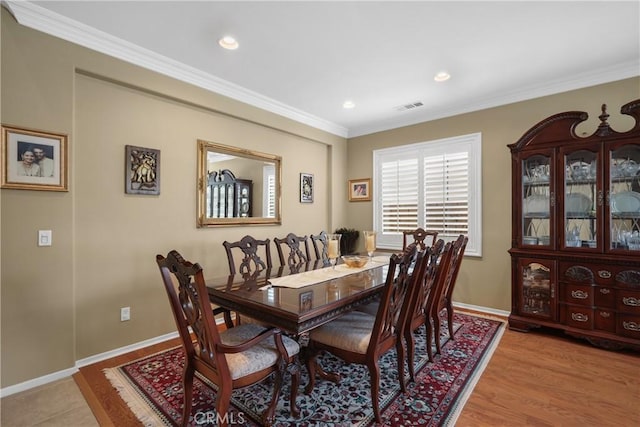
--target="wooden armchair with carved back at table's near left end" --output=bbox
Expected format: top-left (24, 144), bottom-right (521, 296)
top-left (156, 250), bottom-right (300, 426)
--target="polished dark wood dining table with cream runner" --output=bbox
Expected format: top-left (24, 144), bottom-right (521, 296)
top-left (207, 260), bottom-right (388, 337)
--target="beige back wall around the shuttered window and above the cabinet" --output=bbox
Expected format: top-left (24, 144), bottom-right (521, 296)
top-left (347, 78), bottom-right (640, 318)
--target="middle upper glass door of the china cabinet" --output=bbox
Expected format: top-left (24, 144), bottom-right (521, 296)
top-left (562, 148), bottom-right (603, 249)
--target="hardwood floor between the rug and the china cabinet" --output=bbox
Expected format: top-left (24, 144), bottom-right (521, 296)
top-left (457, 330), bottom-right (640, 427)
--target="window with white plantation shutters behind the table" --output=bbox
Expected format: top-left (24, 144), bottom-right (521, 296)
top-left (373, 133), bottom-right (482, 256)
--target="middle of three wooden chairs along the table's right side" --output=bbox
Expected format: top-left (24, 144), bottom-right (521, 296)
top-left (403, 239), bottom-right (452, 380)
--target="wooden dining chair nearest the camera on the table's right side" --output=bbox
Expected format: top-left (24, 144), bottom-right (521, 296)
top-left (306, 245), bottom-right (424, 422)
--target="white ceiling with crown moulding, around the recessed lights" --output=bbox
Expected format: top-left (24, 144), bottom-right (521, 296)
top-left (4, 0), bottom-right (640, 137)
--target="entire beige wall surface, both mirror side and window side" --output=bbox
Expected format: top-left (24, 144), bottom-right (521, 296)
top-left (0, 9), bottom-right (640, 387)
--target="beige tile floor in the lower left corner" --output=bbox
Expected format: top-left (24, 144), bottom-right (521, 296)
top-left (0, 377), bottom-right (98, 427)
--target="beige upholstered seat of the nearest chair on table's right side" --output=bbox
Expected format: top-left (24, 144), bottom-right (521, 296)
top-left (309, 311), bottom-right (376, 354)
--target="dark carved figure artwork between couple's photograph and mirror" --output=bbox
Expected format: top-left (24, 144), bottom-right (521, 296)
top-left (124, 145), bottom-right (160, 195)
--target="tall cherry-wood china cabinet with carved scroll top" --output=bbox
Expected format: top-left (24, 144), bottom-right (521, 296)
top-left (509, 99), bottom-right (640, 350)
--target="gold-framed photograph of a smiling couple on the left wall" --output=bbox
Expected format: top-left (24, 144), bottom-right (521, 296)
top-left (0, 125), bottom-right (69, 191)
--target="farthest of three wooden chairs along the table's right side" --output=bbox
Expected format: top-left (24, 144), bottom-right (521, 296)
top-left (432, 234), bottom-right (469, 344)
